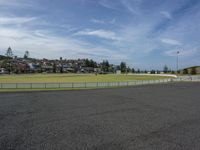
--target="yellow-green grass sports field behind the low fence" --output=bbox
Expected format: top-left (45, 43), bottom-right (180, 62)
top-left (0, 74), bottom-right (172, 83)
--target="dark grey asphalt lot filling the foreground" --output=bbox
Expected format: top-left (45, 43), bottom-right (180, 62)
top-left (0, 82), bottom-right (200, 150)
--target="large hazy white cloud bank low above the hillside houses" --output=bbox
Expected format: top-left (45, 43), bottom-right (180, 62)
top-left (0, 26), bottom-right (126, 61)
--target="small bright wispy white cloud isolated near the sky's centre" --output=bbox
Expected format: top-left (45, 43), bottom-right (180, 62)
top-left (74, 29), bottom-right (120, 40)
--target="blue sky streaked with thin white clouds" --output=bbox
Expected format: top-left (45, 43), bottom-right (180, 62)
top-left (0, 0), bottom-right (200, 70)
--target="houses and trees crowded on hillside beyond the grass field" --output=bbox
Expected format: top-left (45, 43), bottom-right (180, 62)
top-left (0, 55), bottom-right (110, 74)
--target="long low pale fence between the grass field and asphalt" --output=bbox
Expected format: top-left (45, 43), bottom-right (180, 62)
top-left (0, 79), bottom-right (172, 89)
